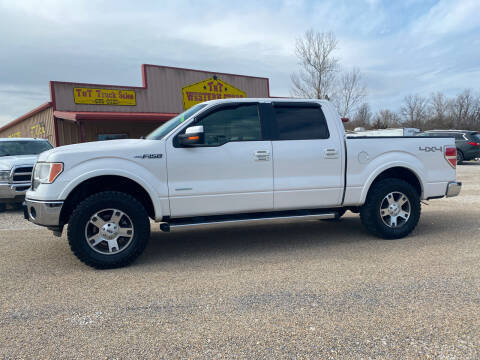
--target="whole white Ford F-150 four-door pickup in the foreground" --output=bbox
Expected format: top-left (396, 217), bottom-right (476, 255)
top-left (25, 99), bottom-right (461, 268)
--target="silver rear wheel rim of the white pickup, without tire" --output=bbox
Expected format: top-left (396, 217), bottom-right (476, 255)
top-left (380, 191), bottom-right (411, 228)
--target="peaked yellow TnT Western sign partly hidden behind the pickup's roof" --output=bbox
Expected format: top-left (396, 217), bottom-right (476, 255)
top-left (182, 76), bottom-right (247, 110)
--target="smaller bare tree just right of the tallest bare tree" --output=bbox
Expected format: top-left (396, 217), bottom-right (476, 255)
top-left (333, 68), bottom-right (367, 117)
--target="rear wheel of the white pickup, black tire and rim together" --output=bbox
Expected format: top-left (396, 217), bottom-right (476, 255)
top-left (360, 179), bottom-right (421, 239)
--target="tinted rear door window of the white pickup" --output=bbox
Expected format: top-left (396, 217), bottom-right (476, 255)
top-left (274, 104), bottom-right (330, 140)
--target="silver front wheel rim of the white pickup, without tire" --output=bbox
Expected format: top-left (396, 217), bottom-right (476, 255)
top-left (85, 209), bottom-right (134, 255)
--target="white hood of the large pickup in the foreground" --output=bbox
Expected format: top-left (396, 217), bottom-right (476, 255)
top-left (38, 139), bottom-right (162, 165)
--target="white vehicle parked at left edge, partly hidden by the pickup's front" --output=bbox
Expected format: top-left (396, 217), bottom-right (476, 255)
top-left (0, 138), bottom-right (52, 211)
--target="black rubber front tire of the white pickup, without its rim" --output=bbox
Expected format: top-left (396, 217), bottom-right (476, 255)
top-left (67, 191), bottom-right (150, 269)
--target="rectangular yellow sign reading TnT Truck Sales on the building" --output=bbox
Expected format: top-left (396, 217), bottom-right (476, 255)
top-left (73, 88), bottom-right (136, 106)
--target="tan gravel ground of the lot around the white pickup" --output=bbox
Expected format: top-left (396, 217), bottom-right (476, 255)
top-left (0, 164), bottom-right (480, 359)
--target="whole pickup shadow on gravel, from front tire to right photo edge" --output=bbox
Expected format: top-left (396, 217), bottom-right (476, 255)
top-left (134, 210), bottom-right (478, 266)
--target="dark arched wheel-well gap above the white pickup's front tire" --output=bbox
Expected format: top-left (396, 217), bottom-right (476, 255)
top-left (60, 175), bottom-right (158, 224)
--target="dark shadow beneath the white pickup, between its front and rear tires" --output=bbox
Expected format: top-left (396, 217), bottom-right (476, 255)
top-left (138, 217), bottom-right (366, 263)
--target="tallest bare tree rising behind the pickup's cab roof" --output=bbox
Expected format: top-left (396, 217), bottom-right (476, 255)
top-left (291, 30), bottom-right (338, 99)
